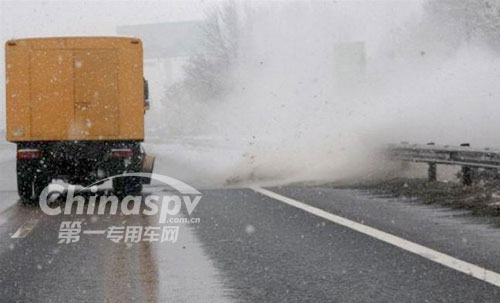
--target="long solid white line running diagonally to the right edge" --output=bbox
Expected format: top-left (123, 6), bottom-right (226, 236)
top-left (251, 187), bottom-right (500, 287)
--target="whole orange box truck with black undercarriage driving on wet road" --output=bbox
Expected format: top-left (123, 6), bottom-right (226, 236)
top-left (5, 37), bottom-right (154, 201)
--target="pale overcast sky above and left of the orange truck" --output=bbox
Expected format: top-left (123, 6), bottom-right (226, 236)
top-left (0, 0), bottom-right (208, 129)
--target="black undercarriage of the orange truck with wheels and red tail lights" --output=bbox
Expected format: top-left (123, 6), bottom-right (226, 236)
top-left (16, 141), bottom-right (148, 202)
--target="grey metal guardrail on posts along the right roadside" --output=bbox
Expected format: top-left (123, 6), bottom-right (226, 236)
top-left (387, 142), bottom-right (500, 185)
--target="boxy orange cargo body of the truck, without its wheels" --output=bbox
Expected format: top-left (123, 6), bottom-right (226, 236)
top-left (5, 37), bottom-right (144, 142)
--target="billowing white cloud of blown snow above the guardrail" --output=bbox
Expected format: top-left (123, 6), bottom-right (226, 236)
top-left (153, 1), bottom-right (500, 185)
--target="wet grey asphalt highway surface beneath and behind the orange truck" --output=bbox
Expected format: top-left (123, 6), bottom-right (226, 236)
top-left (0, 147), bottom-right (500, 303)
